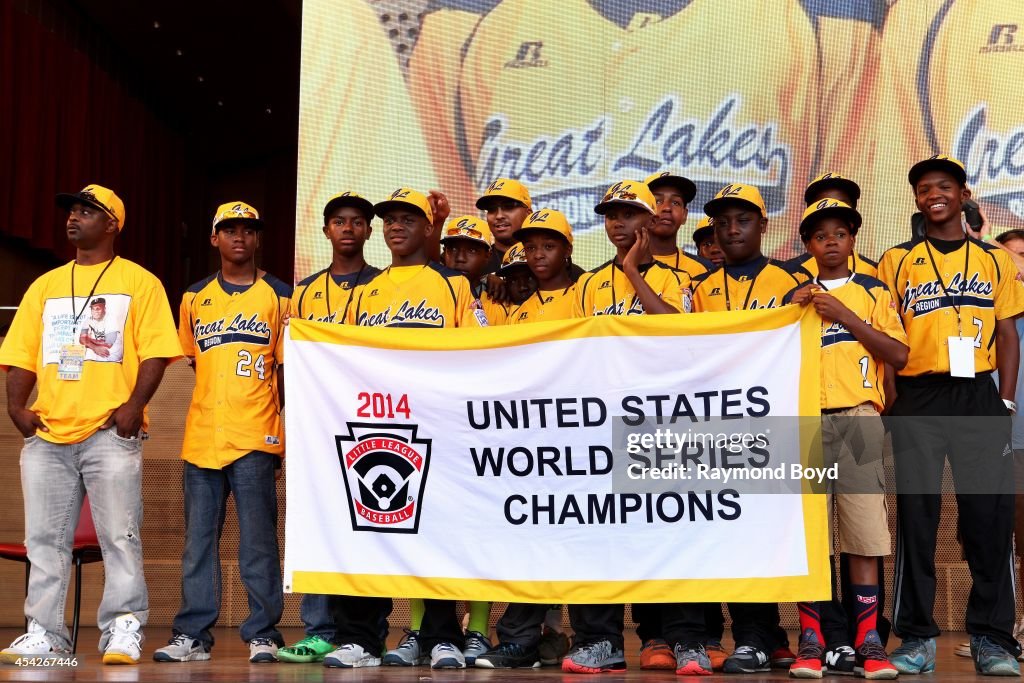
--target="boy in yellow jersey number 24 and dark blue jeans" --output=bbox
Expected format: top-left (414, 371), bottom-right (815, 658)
top-left (153, 202), bottom-right (292, 663)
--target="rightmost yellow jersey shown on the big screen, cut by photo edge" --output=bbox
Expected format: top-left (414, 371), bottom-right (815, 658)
top-left (861, 0), bottom-right (1024, 253)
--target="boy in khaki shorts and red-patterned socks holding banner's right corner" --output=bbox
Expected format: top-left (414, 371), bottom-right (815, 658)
top-left (784, 199), bottom-right (908, 679)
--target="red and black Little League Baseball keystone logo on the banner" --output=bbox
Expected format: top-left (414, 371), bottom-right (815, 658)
top-left (335, 422), bottom-right (430, 533)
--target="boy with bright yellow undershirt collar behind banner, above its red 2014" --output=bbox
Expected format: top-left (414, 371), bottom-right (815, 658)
top-left (344, 187), bottom-right (487, 669)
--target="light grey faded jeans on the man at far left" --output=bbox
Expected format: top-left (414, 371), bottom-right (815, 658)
top-left (22, 428), bottom-right (150, 651)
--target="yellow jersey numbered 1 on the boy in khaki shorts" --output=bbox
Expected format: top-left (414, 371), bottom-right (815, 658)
top-left (783, 272), bottom-right (907, 412)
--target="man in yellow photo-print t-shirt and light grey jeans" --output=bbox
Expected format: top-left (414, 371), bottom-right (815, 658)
top-left (0, 185), bottom-right (181, 664)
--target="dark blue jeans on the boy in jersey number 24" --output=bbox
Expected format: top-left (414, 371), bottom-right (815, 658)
top-left (172, 451), bottom-right (285, 647)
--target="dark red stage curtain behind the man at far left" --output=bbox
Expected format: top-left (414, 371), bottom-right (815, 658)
top-left (0, 0), bottom-right (187, 288)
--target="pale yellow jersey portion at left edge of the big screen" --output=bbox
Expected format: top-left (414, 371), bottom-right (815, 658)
top-left (295, 0), bottom-right (440, 279)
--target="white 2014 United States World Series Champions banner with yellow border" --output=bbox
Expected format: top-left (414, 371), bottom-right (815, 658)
top-left (285, 306), bottom-right (828, 603)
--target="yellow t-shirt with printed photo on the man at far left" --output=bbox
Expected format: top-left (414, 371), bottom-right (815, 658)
top-left (0, 256), bottom-right (181, 443)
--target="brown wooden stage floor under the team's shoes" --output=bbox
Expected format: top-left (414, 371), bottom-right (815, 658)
top-left (0, 627), bottom-right (991, 683)
